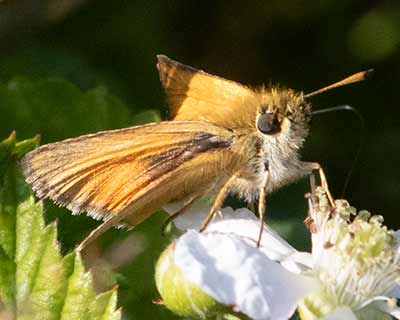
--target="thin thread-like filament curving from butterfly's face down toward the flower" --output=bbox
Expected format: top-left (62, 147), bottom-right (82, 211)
top-left (311, 105), bottom-right (365, 198)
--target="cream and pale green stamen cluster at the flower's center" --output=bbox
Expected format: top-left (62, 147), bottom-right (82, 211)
top-left (311, 189), bottom-right (400, 310)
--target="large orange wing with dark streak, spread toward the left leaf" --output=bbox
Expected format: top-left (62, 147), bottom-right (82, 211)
top-left (22, 121), bottom-right (236, 225)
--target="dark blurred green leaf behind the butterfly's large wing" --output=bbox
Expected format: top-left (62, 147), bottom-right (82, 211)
top-left (0, 77), bottom-right (132, 142)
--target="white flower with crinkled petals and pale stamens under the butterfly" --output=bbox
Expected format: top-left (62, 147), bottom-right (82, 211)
top-left (164, 191), bottom-right (400, 320)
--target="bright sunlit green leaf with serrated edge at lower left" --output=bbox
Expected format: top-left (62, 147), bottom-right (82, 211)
top-left (0, 133), bottom-right (121, 320)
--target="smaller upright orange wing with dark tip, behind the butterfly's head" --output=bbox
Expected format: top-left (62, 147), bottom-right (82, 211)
top-left (157, 55), bottom-right (259, 128)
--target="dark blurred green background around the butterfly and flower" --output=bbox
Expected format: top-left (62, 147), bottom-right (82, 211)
top-left (0, 0), bottom-right (400, 319)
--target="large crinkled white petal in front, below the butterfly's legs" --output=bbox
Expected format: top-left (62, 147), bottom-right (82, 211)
top-left (175, 231), bottom-right (319, 320)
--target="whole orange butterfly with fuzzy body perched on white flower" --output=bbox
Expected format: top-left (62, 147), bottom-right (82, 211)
top-left (22, 55), bottom-right (372, 250)
